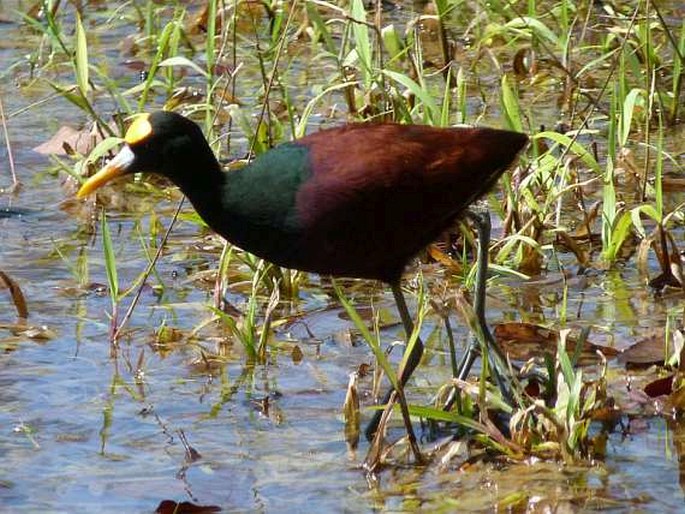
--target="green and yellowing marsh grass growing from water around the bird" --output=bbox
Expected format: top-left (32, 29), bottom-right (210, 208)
top-left (0, 0), bottom-right (685, 505)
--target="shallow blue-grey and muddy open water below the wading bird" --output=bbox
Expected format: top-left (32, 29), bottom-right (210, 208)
top-left (0, 2), bottom-right (685, 512)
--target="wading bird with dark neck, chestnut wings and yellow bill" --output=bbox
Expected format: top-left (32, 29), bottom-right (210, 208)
top-left (77, 111), bottom-right (528, 452)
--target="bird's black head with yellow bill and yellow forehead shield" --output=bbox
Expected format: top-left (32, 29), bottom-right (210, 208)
top-left (77, 111), bottom-right (216, 198)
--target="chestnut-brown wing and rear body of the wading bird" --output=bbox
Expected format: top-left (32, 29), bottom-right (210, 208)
top-left (296, 124), bottom-right (527, 282)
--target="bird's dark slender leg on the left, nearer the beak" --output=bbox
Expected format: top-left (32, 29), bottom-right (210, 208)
top-left (366, 283), bottom-right (423, 460)
